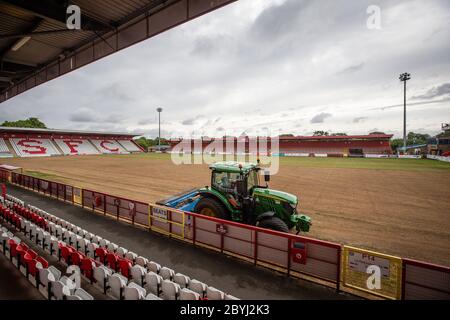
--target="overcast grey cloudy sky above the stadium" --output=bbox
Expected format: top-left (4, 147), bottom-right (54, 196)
top-left (0, 0), bottom-right (450, 137)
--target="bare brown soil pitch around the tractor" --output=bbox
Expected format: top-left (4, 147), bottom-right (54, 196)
top-left (2, 156), bottom-right (450, 265)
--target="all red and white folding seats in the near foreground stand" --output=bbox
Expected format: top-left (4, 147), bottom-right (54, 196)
top-left (0, 195), bottom-right (237, 300)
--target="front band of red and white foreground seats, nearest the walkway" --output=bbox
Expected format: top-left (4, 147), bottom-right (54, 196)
top-left (2, 197), bottom-right (236, 300)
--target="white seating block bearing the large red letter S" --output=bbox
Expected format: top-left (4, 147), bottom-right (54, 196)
top-left (9, 137), bottom-right (60, 157)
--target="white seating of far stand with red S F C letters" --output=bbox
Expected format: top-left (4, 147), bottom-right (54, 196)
top-left (0, 137), bottom-right (141, 157)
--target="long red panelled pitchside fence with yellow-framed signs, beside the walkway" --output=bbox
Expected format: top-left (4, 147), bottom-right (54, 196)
top-left (0, 169), bottom-right (450, 299)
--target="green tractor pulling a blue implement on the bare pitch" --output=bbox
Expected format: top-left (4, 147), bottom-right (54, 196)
top-left (158, 161), bottom-right (311, 233)
